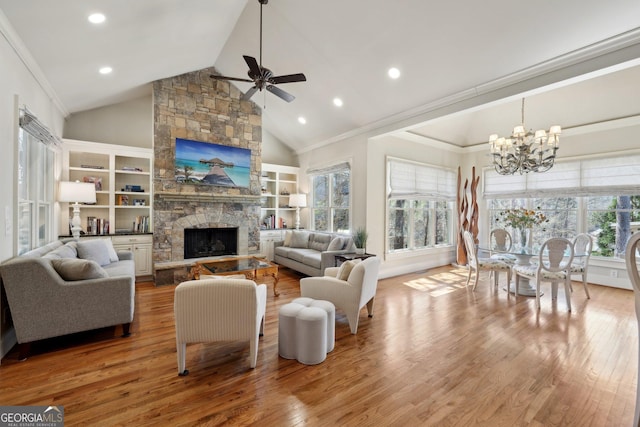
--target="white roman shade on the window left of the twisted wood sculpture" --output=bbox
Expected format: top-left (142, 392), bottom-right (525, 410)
top-left (387, 157), bottom-right (456, 200)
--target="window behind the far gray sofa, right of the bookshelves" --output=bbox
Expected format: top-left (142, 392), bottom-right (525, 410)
top-left (308, 163), bottom-right (351, 233)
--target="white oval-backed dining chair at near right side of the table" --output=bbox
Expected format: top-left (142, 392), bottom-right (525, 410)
top-left (513, 237), bottom-right (573, 311)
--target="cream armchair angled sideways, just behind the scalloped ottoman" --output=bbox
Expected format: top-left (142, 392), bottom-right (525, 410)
top-left (300, 257), bottom-right (380, 334)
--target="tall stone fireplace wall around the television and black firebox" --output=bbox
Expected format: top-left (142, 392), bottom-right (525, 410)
top-left (153, 68), bottom-right (262, 272)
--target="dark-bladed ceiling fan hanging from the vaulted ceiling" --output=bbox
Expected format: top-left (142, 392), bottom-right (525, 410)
top-left (210, 0), bottom-right (307, 102)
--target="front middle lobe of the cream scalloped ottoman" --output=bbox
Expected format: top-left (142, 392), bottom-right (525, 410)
top-left (296, 306), bottom-right (327, 365)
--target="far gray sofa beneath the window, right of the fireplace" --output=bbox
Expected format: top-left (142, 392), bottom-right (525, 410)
top-left (273, 230), bottom-right (355, 276)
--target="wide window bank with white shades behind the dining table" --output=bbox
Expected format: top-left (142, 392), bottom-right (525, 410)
top-left (484, 154), bottom-right (640, 258)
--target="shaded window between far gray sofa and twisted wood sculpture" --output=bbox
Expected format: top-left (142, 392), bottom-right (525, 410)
top-left (387, 158), bottom-right (456, 253)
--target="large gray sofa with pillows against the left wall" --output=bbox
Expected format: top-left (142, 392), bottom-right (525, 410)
top-left (0, 239), bottom-right (135, 359)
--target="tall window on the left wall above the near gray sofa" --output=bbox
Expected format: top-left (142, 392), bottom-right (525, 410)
top-left (17, 122), bottom-right (55, 255)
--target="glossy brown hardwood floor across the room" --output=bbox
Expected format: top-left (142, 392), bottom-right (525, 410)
top-left (0, 267), bottom-right (638, 426)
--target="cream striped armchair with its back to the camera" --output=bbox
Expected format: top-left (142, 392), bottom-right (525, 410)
top-left (173, 279), bottom-right (267, 375)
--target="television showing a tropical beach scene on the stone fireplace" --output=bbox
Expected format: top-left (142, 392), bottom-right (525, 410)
top-left (175, 138), bottom-right (251, 188)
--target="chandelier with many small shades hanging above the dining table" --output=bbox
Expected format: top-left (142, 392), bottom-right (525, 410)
top-left (489, 98), bottom-right (562, 175)
